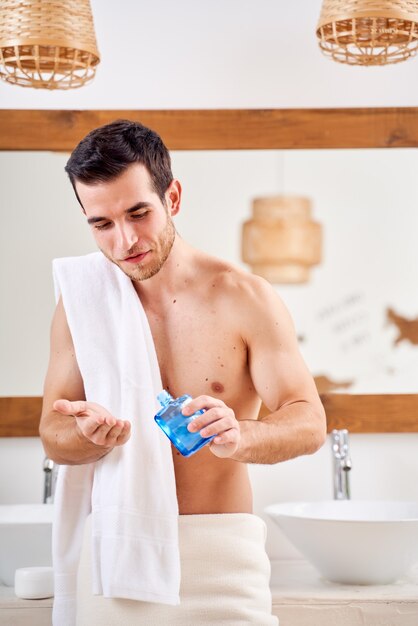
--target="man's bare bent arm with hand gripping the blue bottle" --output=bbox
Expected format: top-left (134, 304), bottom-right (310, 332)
top-left (182, 276), bottom-right (326, 464)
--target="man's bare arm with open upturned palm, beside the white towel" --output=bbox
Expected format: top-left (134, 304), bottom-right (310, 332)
top-left (39, 300), bottom-right (130, 465)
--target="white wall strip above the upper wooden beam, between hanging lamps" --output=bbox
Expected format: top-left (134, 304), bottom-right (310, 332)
top-left (0, 0), bottom-right (418, 109)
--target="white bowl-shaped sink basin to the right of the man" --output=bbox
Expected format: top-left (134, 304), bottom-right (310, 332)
top-left (265, 500), bottom-right (418, 585)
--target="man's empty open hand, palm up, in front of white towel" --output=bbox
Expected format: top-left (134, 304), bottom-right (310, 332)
top-left (53, 400), bottom-right (131, 448)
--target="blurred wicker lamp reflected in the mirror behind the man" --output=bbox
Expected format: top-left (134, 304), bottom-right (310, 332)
top-left (242, 196), bottom-right (322, 284)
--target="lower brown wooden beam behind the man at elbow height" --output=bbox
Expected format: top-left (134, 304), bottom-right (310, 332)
top-left (0, 393), bottom-right (418, 437)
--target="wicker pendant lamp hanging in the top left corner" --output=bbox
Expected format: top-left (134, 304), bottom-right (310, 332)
top-left (0, 0), bottom-right (100, 89)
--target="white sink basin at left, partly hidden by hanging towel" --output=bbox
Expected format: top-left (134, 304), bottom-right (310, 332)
top-left (0, 504), bottom-right (54, 587)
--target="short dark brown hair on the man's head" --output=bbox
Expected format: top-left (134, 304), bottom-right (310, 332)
top-left (65, 120), bottom-right (173, 204)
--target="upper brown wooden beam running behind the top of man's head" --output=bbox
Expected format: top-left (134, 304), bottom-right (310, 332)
top-left (0, 107), bottom-right (418, 152)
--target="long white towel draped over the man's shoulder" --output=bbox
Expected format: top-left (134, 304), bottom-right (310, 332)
top-left (53, 252), bottom-right (180, 626)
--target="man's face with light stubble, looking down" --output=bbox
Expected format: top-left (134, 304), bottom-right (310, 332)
top-left (76, 163), bottom-right (175, 281)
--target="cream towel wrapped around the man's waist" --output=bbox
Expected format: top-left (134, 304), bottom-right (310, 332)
top-left (77, 513), bottom-right (278, 626)
